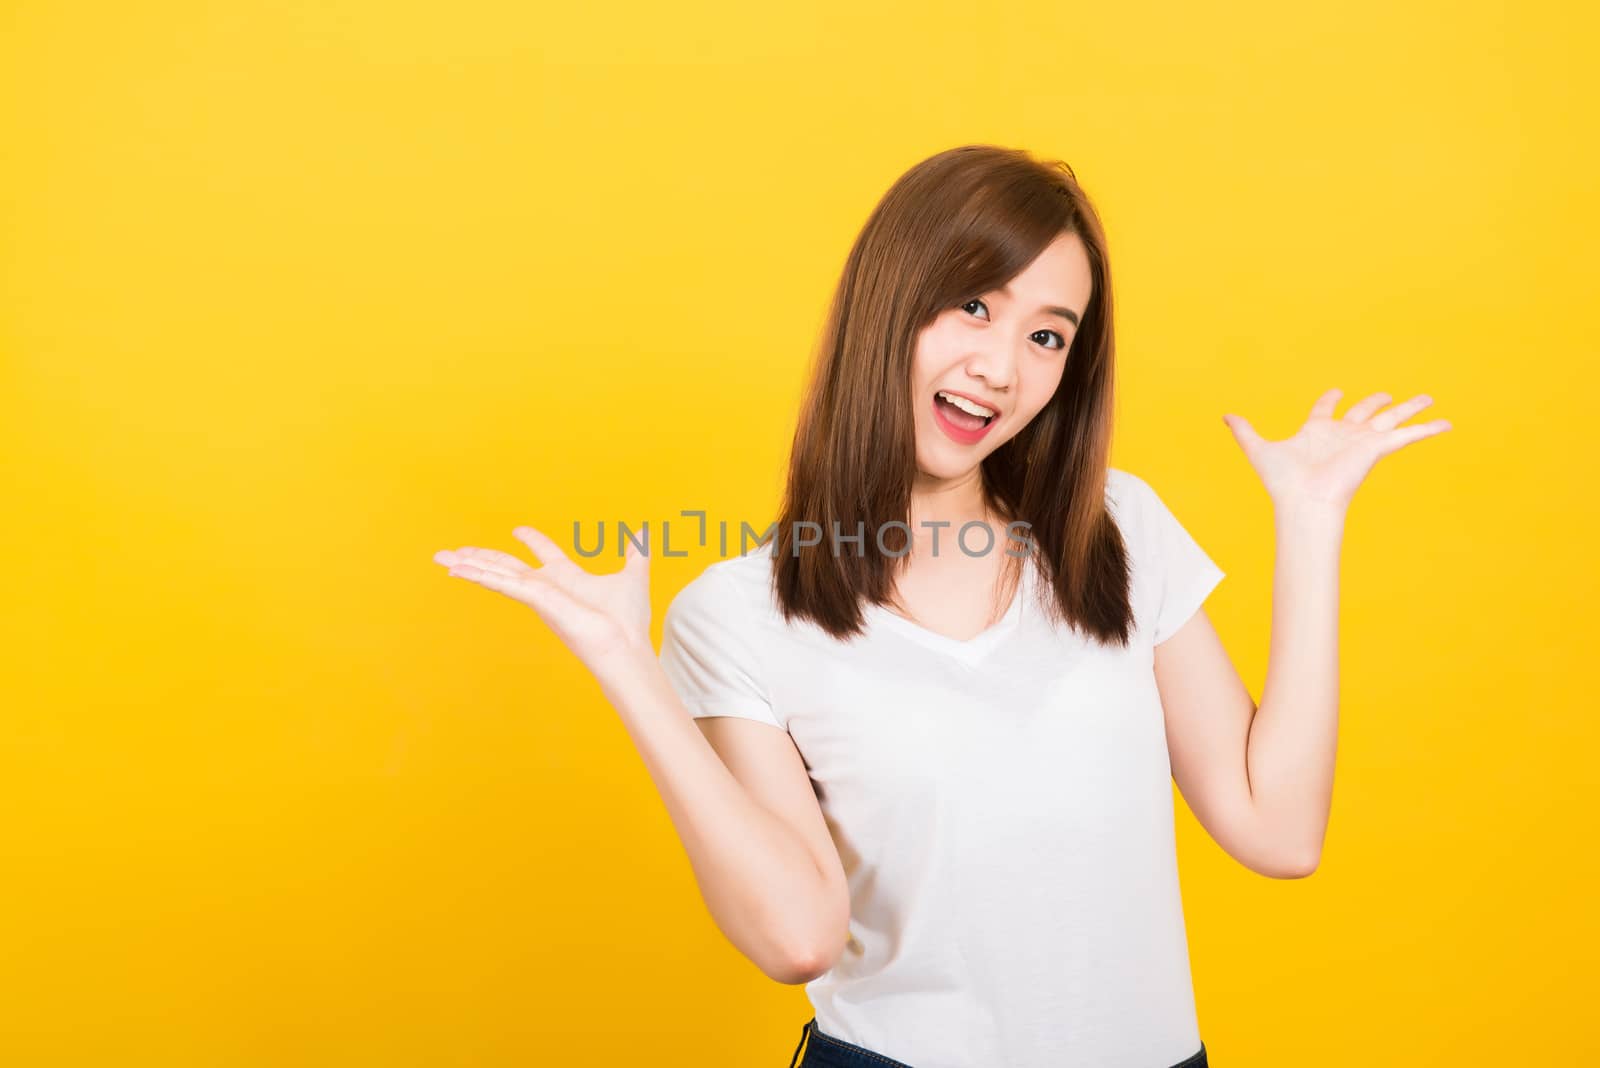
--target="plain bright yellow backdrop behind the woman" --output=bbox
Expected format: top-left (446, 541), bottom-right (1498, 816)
top-left (0, 0), bottom-right (1600, 1068)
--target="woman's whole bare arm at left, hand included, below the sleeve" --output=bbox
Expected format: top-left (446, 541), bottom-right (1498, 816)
top-left (434, 526), bottom-right (850, 983)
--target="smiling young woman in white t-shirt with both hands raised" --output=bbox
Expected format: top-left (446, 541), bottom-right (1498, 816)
top-left (435, 145), bottom-right (1450, 1068)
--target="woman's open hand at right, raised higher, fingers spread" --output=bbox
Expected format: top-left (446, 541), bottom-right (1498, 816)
top-left (1222, 389), bottom-right (1450, 508)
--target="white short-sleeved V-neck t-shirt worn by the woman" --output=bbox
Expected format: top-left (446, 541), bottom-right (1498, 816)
top-left (661, 468), bottom-right (1224, 1068)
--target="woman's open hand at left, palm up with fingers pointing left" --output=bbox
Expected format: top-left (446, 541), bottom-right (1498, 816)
top-left (434, 526), bottom-right (654, 675)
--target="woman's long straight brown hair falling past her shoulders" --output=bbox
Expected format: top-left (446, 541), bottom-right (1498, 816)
top-left (773, 144), bottom-right (1133, 644)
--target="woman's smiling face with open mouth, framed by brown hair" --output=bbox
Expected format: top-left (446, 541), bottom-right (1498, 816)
top-left (912, 233), bottom-right (1091, 481)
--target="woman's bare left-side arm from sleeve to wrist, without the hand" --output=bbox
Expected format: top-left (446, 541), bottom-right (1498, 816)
top-left (597, 646), bottom-right (850, 983)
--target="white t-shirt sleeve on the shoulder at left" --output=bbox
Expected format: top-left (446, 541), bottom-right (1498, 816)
top-left (659, 572), bottom-right (786, 731)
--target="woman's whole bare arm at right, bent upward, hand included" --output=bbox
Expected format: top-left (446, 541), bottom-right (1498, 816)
top-left (1155, 390), bottom-right (1450, 878)
